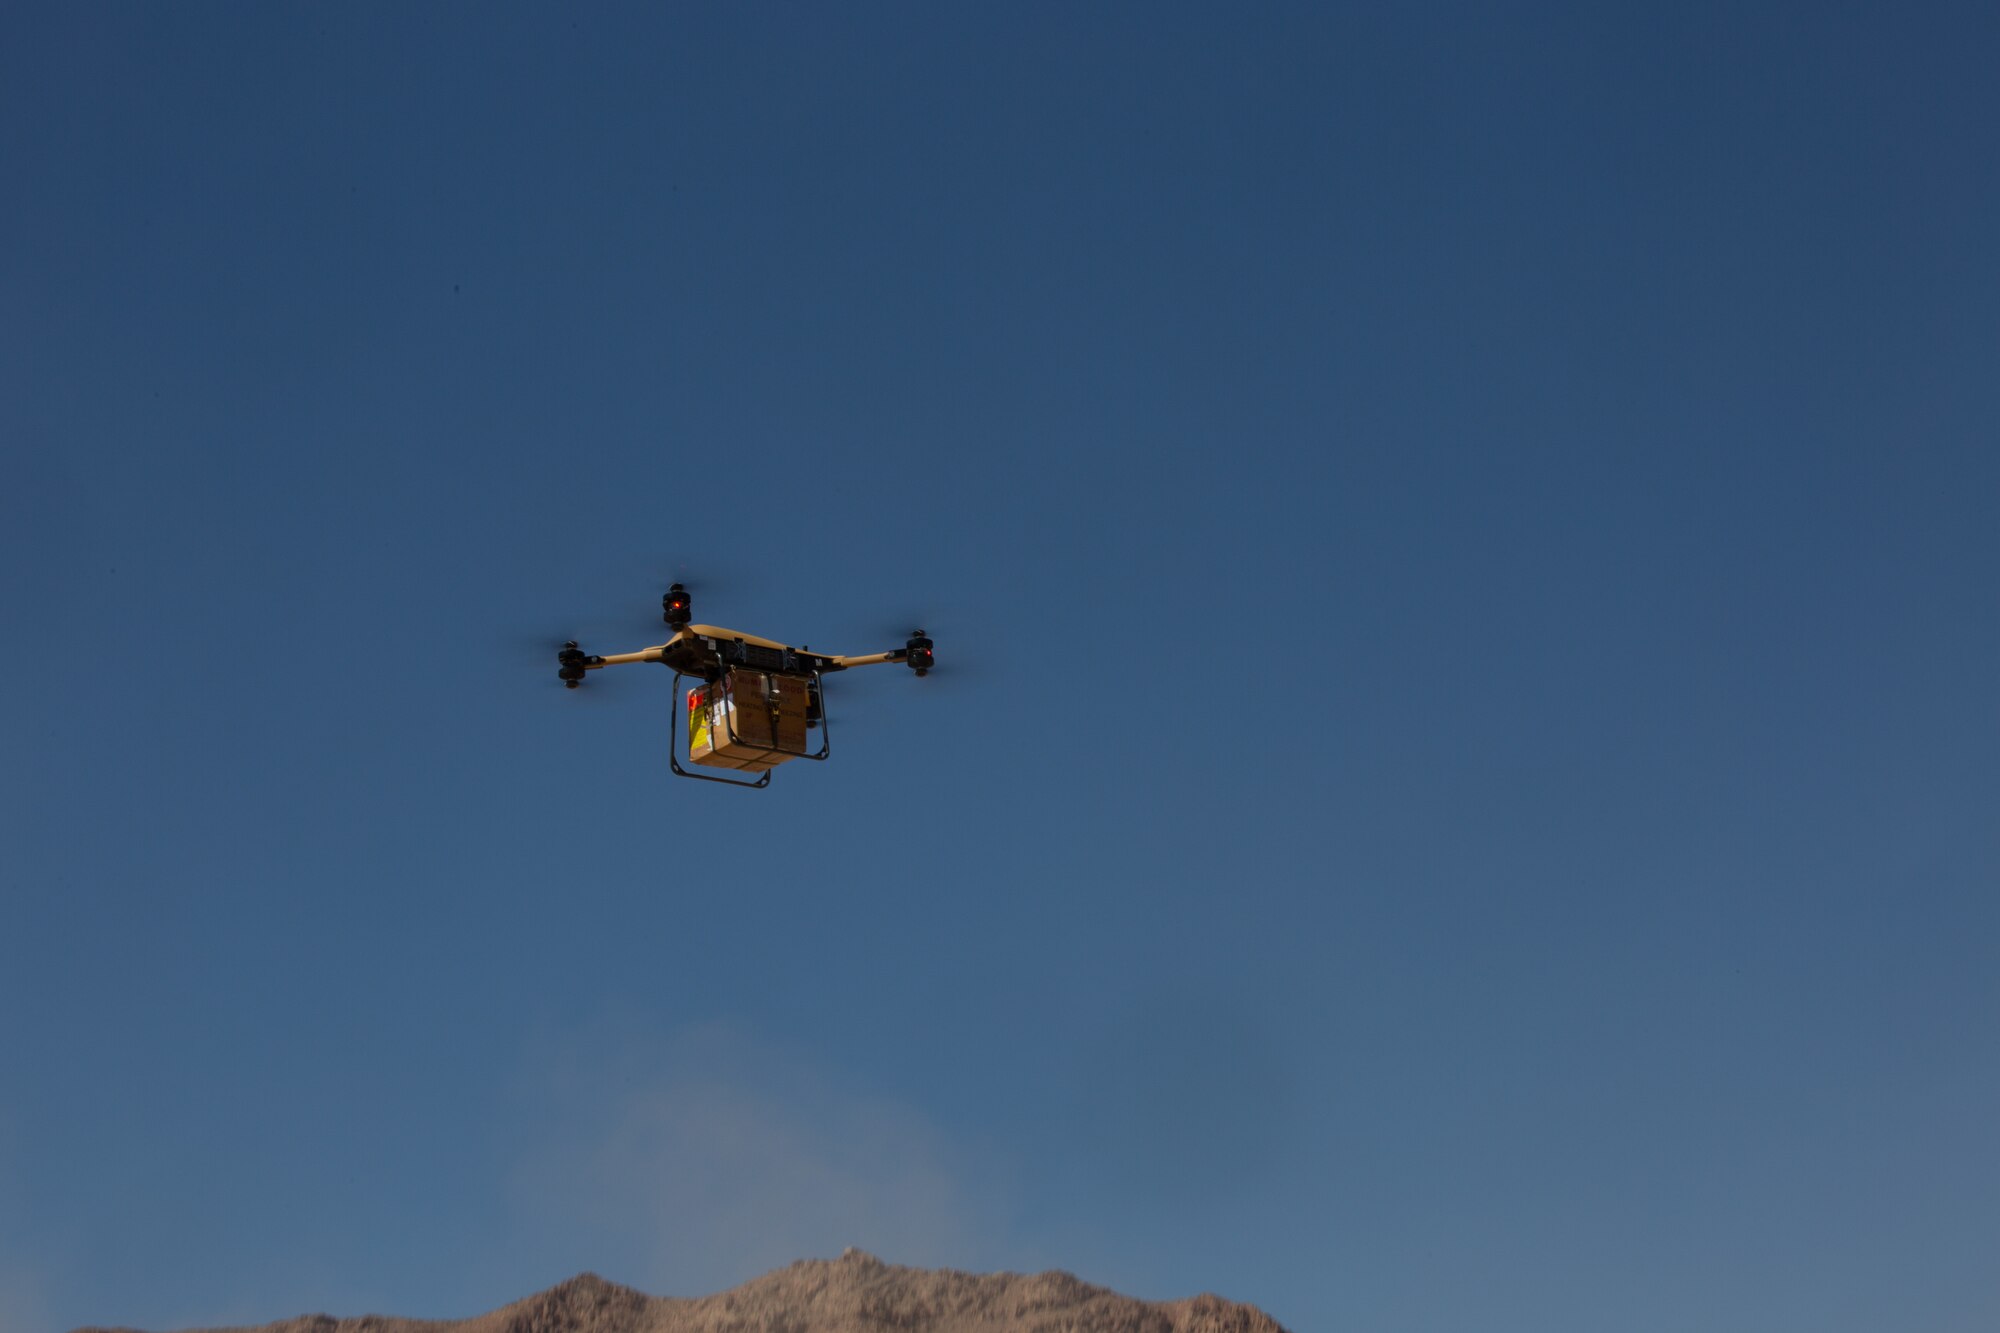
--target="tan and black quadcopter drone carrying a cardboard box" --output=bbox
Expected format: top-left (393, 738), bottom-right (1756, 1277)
top-left (556, 582), bottom-right (938, 787)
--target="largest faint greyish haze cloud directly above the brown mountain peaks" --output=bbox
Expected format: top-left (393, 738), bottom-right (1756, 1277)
top-left (510, 1027), bottom-right (1006, 1295)
